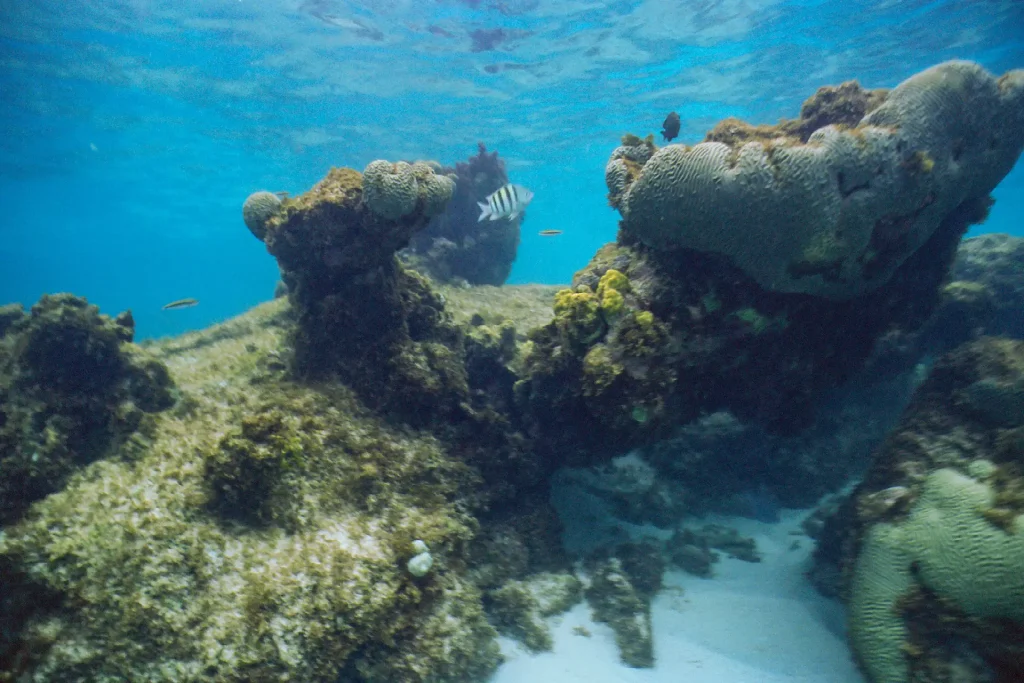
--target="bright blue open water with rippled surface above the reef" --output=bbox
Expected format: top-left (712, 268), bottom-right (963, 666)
top-left (0, 0), bottom-right (1024, 337)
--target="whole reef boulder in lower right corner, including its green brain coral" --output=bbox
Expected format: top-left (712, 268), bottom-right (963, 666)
top-left (816, 338), bottom-right (1024, 683)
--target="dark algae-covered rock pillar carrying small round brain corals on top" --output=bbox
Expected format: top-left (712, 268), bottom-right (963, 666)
top-left (266, 162), bottom-right (466, 416)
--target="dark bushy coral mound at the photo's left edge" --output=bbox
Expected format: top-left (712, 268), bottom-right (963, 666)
top-left (0, 294), bottom-right (174, 523)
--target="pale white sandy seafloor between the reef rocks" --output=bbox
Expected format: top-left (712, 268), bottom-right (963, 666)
top-left (490, 481), bottom-right (864, 683)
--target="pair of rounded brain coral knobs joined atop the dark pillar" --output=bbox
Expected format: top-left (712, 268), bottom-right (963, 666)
top-left (362, 160), bottom-right (455, 220)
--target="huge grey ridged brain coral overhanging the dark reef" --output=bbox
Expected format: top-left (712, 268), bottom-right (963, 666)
top-left (606, 61), bottom-right (1024, 298)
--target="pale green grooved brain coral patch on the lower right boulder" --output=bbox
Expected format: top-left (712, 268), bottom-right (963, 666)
top-left (850, 468), bottom-right (1024, 683)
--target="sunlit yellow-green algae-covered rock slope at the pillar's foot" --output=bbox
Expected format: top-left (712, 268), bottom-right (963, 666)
top-left (0, 301), bottom-right (500, 683)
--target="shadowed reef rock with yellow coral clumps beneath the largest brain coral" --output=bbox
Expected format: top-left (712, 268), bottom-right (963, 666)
top-left (516, 187), bottom-right (987, 464)
